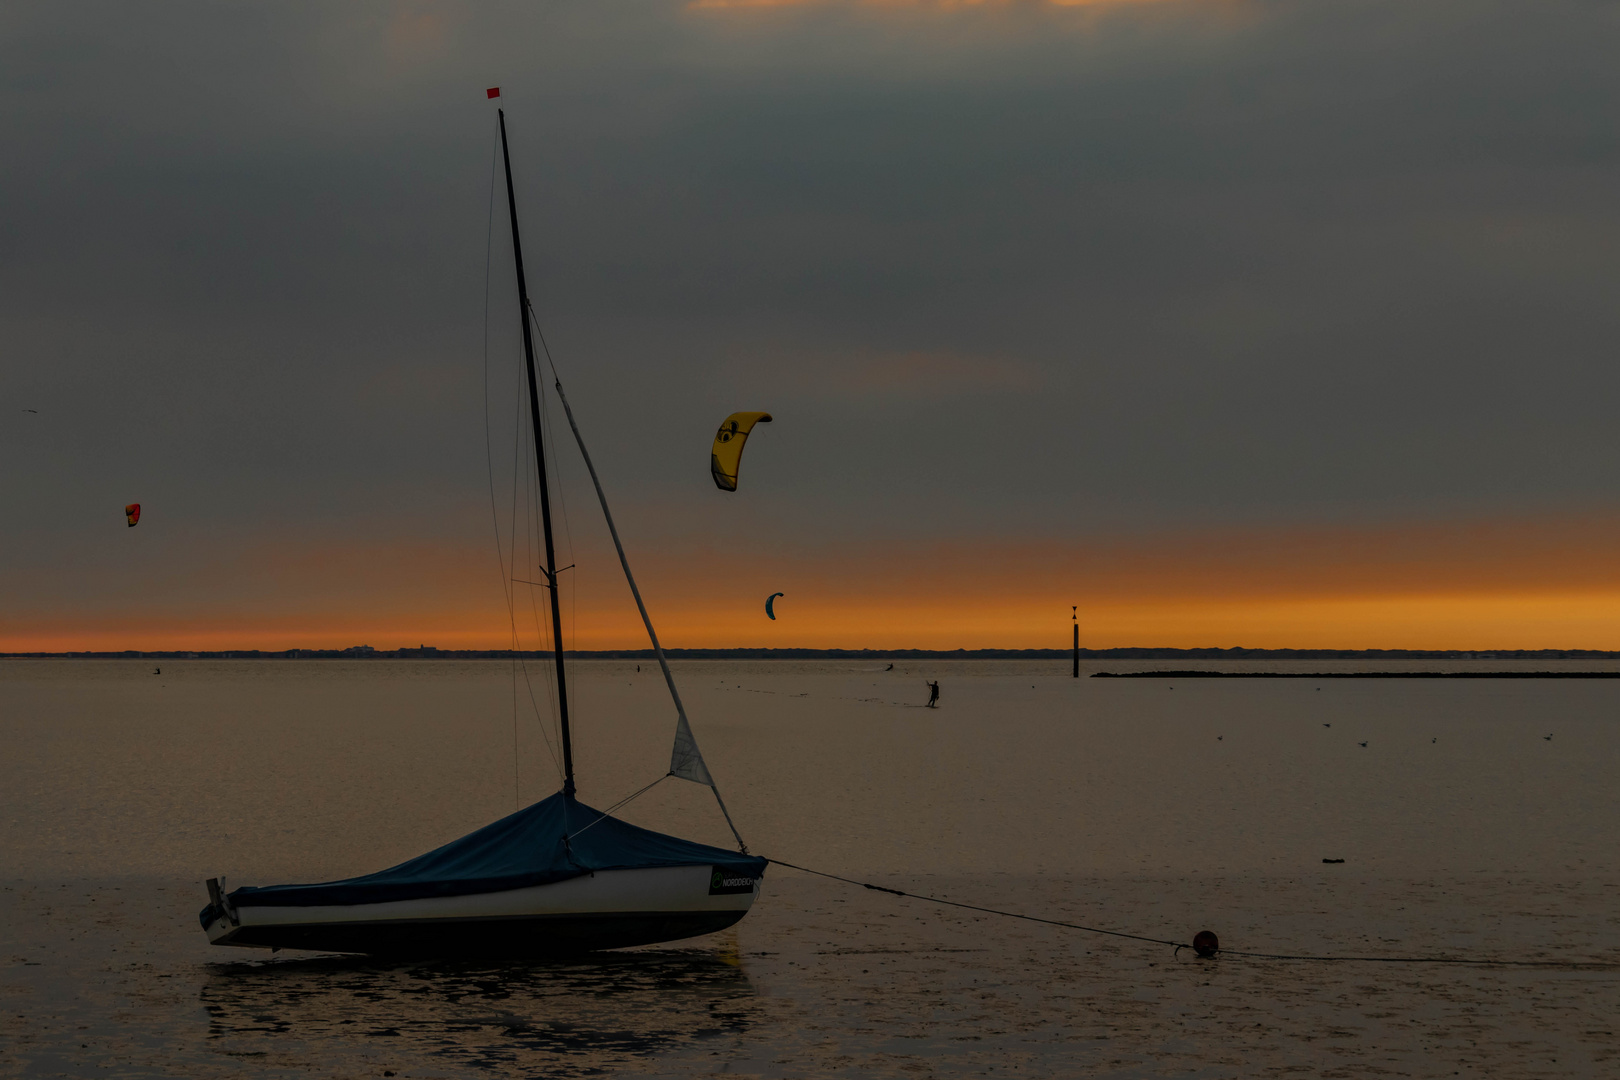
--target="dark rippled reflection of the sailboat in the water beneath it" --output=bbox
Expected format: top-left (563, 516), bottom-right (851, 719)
top-left (199, 947), bottom-right (758, 1075)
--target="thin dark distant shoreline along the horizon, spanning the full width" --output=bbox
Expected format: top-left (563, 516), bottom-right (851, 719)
top-left (0, 646), bottom-right (1620, 663)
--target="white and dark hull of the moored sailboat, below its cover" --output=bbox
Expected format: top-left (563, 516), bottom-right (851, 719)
top-left (204, 866), bottom-right (760, 957)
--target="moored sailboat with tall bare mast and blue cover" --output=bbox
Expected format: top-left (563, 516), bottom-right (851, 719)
top-left (199, 107), bottom-right (766, 957)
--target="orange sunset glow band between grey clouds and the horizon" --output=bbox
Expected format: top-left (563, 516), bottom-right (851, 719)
top-left (9, 517), bottom-right (1620, 653)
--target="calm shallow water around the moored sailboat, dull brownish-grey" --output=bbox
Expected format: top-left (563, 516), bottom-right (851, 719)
top-left (0, 661), bottom-right (1620, 1077)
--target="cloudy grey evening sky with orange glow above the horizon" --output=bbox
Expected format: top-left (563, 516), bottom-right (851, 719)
top-left (0, 0), bottom-right (1620, 651)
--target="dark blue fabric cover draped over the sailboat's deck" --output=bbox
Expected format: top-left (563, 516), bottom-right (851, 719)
top-left (230, 793), bottom-right (766, 907)
